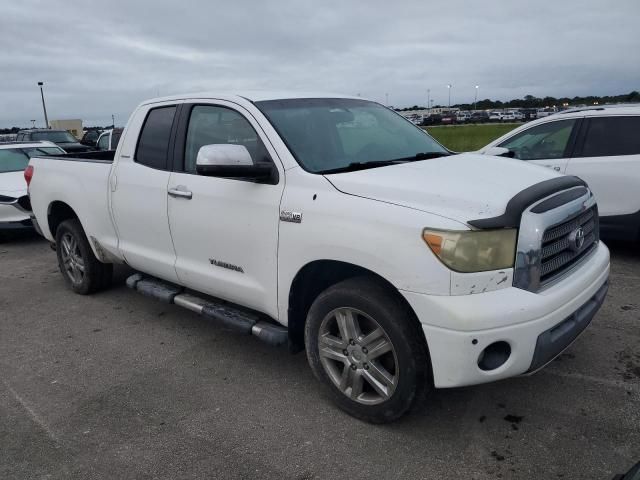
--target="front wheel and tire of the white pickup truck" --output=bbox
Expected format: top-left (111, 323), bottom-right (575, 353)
top-left (305, 277), bottom-right (432, 423)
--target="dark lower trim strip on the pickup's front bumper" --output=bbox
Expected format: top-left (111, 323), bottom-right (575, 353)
top-left (528, 281), bottom-right (609, 373)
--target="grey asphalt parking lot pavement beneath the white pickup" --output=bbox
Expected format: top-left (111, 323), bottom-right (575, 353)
top-left (0, 236), bottom-right (640, 480)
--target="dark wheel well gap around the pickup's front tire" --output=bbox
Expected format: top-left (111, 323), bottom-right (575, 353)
top-left (287, 259), bottom-right (426, 352)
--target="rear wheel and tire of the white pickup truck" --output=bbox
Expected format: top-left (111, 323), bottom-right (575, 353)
top-left (56, 219), bottom-right (113, 295)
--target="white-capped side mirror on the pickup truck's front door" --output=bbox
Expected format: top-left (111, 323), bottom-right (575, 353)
top-left (196, 143), bottom-right (278, 185)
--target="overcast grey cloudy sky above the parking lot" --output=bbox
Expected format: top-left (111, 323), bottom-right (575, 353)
top-left (0, 0), bottom-right (640, 127)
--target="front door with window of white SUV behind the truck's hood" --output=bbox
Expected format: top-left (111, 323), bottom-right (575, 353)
top-left (497, 118), bottom-right (581, 173)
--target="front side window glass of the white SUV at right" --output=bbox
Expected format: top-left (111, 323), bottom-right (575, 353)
top-left (498, 119), bottom-right (576, 160)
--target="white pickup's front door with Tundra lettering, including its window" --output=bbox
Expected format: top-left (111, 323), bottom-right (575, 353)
top-left (169, 102), bottom-right (284, 317)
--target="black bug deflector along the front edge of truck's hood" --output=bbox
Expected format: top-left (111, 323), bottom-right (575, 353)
top-left (467, 176), bottom-right (587, 229)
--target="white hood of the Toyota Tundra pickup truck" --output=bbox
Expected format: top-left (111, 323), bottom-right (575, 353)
top-left (326, 153), bottom-right (561, 223)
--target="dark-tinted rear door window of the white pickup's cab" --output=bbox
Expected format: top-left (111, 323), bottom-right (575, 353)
top-left (135, 106), bottom-right (176, 170)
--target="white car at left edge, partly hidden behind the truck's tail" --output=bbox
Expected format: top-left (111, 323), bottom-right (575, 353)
top-left (0, 142), bottom-right (65, 236)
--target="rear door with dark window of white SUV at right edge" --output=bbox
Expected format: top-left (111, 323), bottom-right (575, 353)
top-left (567, 115), bottom-right (640, 217)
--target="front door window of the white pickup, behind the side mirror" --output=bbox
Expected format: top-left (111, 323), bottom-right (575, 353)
top-left (184, 105), bottom-right (271, 173)
